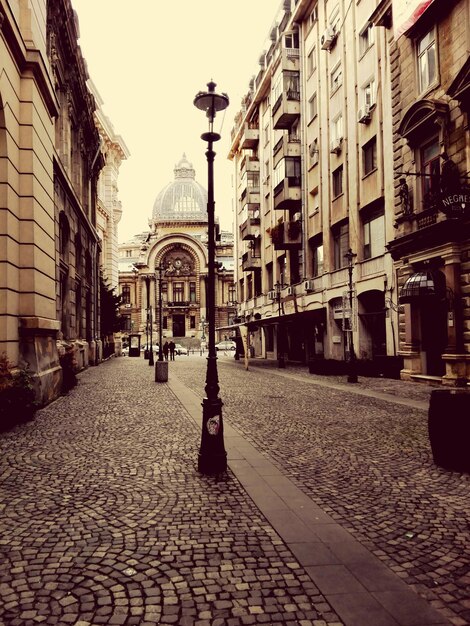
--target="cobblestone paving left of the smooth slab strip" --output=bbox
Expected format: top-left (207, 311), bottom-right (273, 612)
top-left (0, 357), bottom-right (341, 626)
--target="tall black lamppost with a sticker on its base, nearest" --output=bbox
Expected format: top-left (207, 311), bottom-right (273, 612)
top-left (194, 81), bottom-right (229, 474)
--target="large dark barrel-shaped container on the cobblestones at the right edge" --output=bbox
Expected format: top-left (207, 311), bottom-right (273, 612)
top-left (428, 389), bottom-right (470, 472)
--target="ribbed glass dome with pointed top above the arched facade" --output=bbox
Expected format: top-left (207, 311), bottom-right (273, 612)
top-left (152, 154), bottom-right (207, 222)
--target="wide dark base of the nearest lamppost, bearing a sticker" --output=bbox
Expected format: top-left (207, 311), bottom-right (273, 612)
top-left (197, 398), bottom-right (227, 474)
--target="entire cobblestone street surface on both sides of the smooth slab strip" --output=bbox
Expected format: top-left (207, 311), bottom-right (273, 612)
top-left (0, 355), bottom-right (470, 626)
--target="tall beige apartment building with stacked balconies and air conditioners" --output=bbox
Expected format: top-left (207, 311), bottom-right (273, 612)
top-left (230, 0), bottom-right (398, 371)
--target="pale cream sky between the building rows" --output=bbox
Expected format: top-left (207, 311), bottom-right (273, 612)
top-left (72, 0), bottom-right (281, 242)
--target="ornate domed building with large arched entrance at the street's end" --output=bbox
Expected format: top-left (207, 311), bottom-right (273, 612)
top-left (119, 155), bottom-right (235, 348)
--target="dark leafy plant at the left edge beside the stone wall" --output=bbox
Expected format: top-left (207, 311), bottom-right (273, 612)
top-left (0, 354), bottom-right (39, 429)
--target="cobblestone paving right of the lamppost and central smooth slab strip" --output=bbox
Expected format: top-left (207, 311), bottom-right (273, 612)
top-left (173, 357), bottom-right (470, 626)
